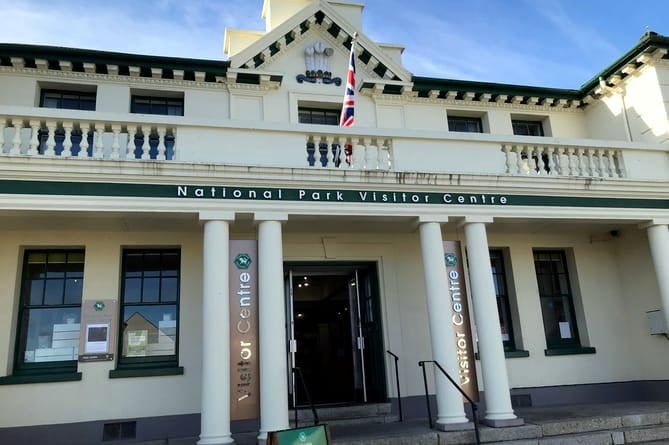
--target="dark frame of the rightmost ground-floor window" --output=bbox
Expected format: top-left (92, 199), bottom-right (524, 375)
top-left (532, 249), bottom-right (582, 351)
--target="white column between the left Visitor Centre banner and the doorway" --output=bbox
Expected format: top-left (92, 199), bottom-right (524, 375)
top-left (255, 213), bottom-right (289, 441)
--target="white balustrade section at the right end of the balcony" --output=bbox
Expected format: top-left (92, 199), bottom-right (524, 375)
top-left (502, 144), bottom-right (625, 178)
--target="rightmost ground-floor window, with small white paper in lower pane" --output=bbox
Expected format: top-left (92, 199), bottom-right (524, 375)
top-left (534, 250), bottom-right (580, 349)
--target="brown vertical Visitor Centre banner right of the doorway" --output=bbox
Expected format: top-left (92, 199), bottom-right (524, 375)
top-left (444, 241), bottom-right (479, 402)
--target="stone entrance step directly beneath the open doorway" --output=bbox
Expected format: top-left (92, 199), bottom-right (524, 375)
top-left (289, 403), bottom-right (398, 426)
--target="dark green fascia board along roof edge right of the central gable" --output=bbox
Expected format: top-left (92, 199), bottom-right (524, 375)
top-left (412, 76), bottom-right (583, 100)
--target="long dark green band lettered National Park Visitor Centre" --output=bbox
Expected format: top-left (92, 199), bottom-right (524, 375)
top-left (0, 180), bottom-right (669, 209)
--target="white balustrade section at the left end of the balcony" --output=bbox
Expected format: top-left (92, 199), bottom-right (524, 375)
top-left (0, 117), bottom-right (176, 160)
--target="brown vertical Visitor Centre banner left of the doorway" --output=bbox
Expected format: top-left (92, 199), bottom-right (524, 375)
top-left (228, 240), bottom-right (260, 420)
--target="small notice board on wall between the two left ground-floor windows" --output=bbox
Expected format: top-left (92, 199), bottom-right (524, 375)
top-left (79, 300), bottom-right (117, 362)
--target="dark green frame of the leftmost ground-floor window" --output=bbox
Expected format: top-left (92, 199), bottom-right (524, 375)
top-left (13, 248), bottom-right (86, 376)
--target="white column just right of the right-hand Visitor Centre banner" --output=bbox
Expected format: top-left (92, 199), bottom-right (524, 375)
top-left (464, 218), bottom-right (523, 426)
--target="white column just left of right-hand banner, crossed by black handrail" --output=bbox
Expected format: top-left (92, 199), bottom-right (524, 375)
top-left (419, 217), bottom-right (469, 430)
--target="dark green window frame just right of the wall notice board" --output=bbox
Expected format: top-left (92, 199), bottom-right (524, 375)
top-left (110, 247), bottom-right (183, 377)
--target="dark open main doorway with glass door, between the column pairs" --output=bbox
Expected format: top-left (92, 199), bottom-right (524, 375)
top-left (285, 262), bottom-right (386, 406)
